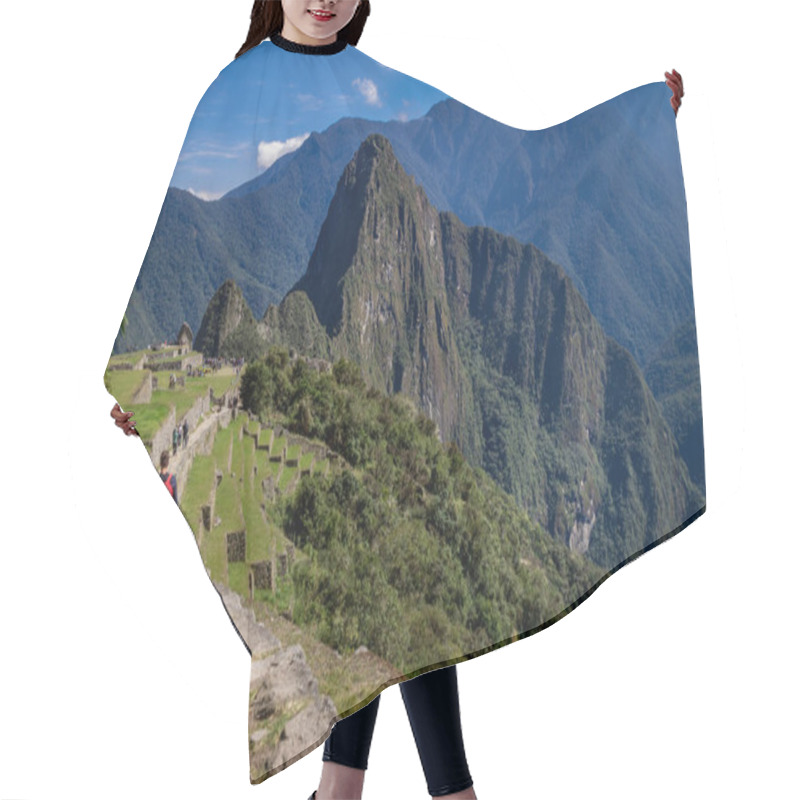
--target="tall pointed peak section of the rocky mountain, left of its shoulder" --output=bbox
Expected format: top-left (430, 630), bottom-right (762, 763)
top-left (294, 135), bottom-right (470, 439)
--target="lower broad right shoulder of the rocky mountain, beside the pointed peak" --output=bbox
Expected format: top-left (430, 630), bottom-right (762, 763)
top-left (432, 198), bottom-right (704, 566)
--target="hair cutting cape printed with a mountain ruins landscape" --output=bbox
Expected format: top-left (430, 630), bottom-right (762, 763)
top-left (105, 31), bottom-right (705, 783)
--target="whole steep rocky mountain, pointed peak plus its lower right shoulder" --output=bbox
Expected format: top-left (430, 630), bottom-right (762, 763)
top-left (216, 134), bottom-right (703, 565)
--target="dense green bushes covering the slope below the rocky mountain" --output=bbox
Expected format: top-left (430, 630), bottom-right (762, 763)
top-left (241, 348), bottom-right (603, 671)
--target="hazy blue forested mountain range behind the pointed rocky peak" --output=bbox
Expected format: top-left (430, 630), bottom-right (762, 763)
top-left (115, 85), bottom-right (693, 366)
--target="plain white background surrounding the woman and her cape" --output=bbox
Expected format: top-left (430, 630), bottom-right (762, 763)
top-left (0, 0), bottom-right (800, 800)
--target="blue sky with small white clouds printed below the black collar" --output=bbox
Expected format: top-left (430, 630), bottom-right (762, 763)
top-left (170, 40), bottom-right (447, 200)
